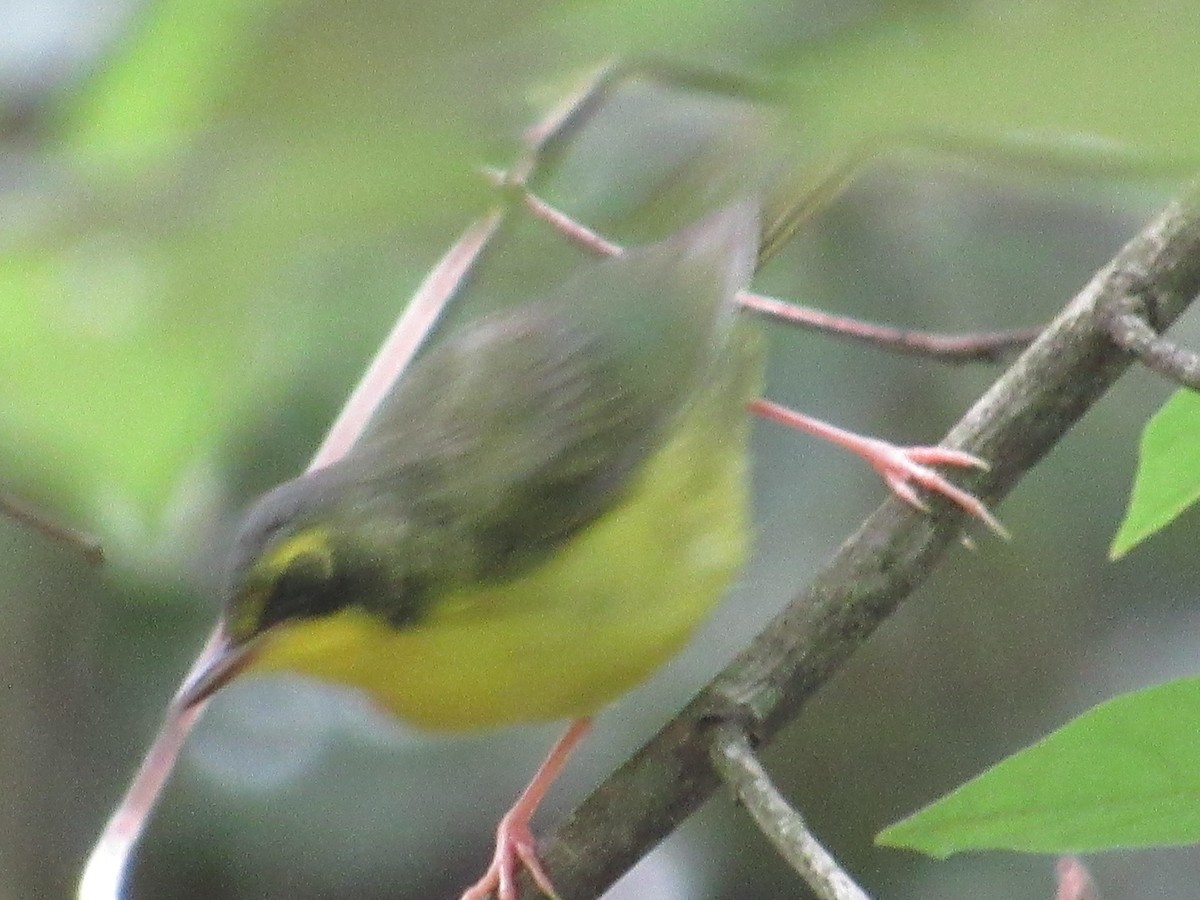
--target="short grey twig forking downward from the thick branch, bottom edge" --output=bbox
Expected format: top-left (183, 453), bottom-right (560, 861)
top-left (712, 722), bottom-right (871, 900)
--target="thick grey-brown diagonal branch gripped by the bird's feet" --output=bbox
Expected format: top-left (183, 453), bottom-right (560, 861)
top-left (511, 187), bottom-right (1200, 898)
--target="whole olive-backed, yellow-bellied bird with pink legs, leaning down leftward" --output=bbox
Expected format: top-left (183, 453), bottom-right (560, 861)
top-left (176, 200), bottom-right (993, 900)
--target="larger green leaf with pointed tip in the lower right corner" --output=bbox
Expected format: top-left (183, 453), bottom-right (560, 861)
top-left (876, 678), bottom-right (1200, 857)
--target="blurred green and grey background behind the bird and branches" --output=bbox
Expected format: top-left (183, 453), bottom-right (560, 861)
top-left (0, 0), bottom-right (1200, 900)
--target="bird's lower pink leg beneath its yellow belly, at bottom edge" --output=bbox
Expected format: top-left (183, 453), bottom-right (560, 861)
top-left (462, 718), bottom-right (592, 900)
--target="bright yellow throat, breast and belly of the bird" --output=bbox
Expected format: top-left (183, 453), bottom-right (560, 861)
top-left (244, 338), bottom-right (749, 728)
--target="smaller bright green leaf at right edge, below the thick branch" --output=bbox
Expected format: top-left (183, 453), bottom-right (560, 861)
top-left (1109, 390), bottom-right (1200, 559)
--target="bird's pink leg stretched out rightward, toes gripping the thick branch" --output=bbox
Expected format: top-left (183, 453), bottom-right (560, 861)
top-left (750, 400), bottom-right (1008, 538)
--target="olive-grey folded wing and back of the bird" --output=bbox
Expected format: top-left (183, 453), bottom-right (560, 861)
top-left (342, 204), bottom-right (757, 577)
